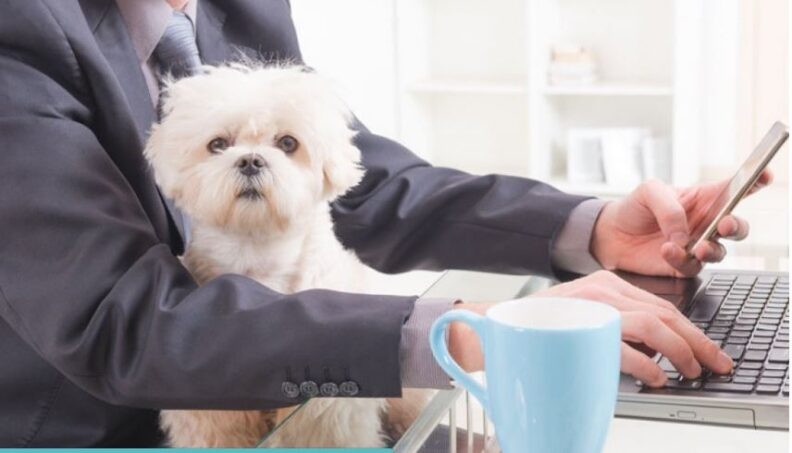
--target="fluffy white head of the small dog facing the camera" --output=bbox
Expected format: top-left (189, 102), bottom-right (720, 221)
top-left (145, 66), bottom-right (363, 233)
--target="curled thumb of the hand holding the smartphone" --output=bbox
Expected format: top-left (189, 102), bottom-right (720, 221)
top-left (639, 181), bottom-right (690, 246)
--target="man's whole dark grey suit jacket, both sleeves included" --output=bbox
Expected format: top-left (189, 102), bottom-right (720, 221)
top-left (0, 0), bottom-right (582, 447)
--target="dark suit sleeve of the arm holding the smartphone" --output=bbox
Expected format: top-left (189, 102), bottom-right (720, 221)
top-left (333, 123), bottom-right (586, 276)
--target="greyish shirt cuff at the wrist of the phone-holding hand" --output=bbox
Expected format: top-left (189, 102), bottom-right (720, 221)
top-left (551, 199), bottom-right (606, 274)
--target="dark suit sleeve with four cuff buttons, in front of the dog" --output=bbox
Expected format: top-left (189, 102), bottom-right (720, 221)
top-left (0, 2), bottom-right (414, 409)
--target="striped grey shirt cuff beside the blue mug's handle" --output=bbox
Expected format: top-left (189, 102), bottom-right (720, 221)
top-left (399, 299), bottom-right (457, 389)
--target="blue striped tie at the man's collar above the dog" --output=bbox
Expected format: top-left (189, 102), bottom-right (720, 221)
top-left (154, 10), bottom-right (201, 79)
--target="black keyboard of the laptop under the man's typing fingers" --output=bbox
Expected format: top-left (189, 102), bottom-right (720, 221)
top-left (639, 274), bottom-right (789, 396)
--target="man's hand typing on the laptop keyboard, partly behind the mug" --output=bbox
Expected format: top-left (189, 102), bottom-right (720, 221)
top-left (448, 271), bottom-right (734, 387)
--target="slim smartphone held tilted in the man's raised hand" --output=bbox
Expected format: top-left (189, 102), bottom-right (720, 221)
top-left (687, 121), bottom-right (789, 255)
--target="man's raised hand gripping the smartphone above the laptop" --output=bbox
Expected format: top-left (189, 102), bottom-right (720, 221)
top-left (591, 171), bottom-right (773, 277)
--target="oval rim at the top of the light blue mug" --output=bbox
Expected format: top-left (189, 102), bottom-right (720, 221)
top-left (485, 297), bottom-right (621, 332)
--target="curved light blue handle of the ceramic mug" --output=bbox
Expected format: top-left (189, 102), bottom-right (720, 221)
top-left (429, 310), bottom-right (489, 412)
